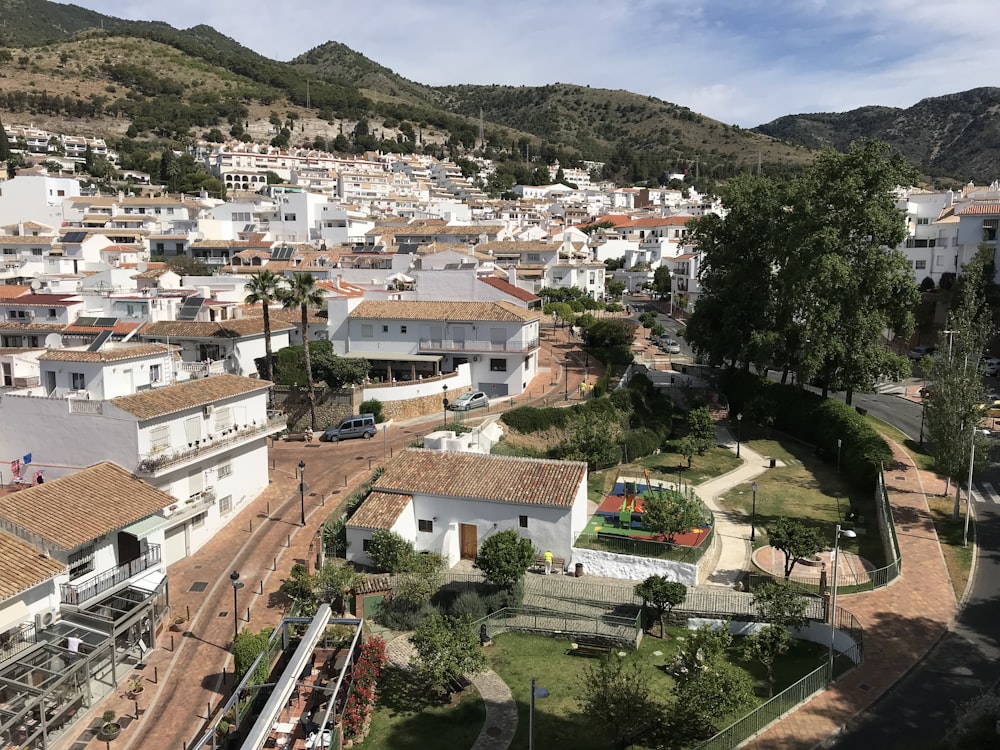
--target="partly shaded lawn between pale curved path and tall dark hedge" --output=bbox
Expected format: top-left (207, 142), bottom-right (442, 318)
top-left (718, 439), bottom-right (885, 568)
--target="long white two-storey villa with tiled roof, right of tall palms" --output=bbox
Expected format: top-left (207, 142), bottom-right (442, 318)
top-left (328, 297), bottom-right (541, 398)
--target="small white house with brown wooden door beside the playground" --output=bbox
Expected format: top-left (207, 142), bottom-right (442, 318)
top-left (347, 449), bottom-right (587, 565)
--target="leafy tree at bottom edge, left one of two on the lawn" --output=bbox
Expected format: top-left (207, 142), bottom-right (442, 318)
top-left (580, 655), bottom-right (663, 747)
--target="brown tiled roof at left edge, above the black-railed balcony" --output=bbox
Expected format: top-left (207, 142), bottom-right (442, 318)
top-left (0, 464), bottom-right (174, 550)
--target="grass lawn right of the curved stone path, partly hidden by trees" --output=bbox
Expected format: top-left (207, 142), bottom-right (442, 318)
top-left (488, 627), bottom-right (826, 750)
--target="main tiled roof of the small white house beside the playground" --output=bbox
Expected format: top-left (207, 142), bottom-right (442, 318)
top-left (376, 449), bottom-right (587, 508)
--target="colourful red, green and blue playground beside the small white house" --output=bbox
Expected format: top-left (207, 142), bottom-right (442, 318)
top-left (584, 474), bottom-right (712, 547)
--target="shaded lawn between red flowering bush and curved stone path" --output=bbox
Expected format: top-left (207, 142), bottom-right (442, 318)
top-left (359, 667), bottom-right (486, 750)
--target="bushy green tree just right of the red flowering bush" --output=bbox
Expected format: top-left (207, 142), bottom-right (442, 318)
top-left (410, 614), bottom-right (487, 695)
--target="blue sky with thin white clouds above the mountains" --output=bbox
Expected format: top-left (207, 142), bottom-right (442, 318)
top-left (77, 0), bottom-right (1000, 127)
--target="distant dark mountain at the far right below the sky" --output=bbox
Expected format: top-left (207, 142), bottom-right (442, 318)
top-left (755, 88), bottom-right (1000, 183)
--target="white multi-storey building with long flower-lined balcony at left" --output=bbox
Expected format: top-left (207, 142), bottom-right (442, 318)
top-left (0, 352), bottom-right (285, 564)
